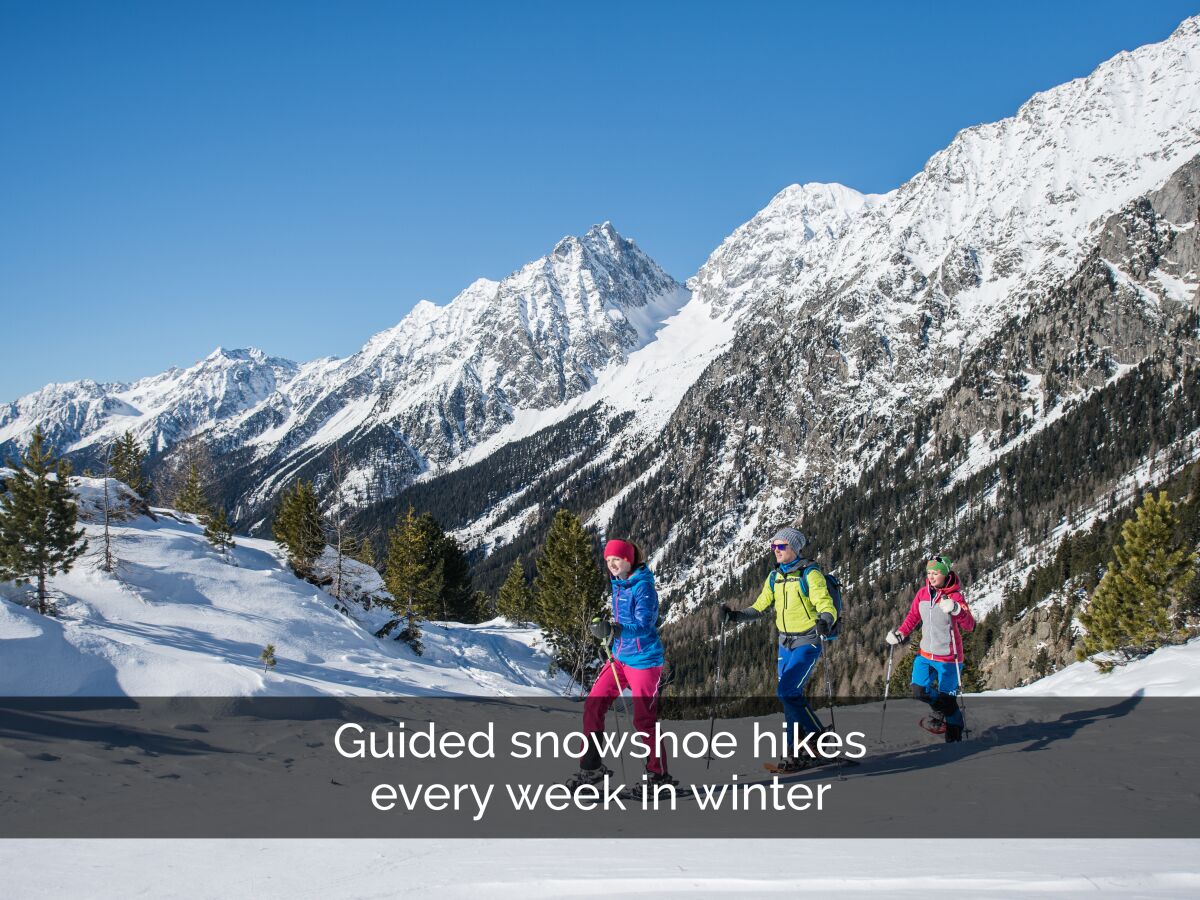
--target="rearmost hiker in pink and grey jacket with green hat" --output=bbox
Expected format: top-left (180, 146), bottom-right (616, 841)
top-left (887, 557), bottom-right (974, 743)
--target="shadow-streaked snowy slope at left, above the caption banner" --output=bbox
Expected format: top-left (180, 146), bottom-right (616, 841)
top-left (0, 479), bottom-right (565, 696)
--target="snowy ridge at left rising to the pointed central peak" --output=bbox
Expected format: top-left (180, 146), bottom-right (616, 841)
top-left (0, 223), bottom-right (689, 520)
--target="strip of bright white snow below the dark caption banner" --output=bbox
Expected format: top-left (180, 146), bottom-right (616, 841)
top-left (0, 840), bottom-right (1200, 900)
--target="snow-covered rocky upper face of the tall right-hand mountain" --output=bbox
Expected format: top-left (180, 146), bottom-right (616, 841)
top-left (451, 18), bottom-right (1200, 593)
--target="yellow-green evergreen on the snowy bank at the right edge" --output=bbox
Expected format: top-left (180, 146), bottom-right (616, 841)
top-left (1078, 491), bottom-right (1196, 668)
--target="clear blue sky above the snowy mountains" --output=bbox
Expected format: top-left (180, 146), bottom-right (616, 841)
top-left (0, 0), bottom-right (1200, 402)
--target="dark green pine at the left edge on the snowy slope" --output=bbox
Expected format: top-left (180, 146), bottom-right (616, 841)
top-left (0, 428), bottom-right (88, 616)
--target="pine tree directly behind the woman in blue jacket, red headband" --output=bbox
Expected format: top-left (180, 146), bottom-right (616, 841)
top-left (534, 509), bottom-right (608, 684)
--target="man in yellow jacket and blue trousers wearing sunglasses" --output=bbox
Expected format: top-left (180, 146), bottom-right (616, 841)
top-left (721, 528), bottom-right (838, 772)
